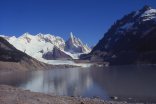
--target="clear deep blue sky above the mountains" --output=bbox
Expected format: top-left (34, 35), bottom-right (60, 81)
top-left (0, 0), bottom-right (156, 46)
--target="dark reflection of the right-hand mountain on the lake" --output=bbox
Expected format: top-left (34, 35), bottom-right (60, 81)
top-left (92, 66), bottom-right (156, 98)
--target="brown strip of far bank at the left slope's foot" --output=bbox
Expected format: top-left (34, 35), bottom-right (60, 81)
top-left (0, 61), bottom-right (79, 72)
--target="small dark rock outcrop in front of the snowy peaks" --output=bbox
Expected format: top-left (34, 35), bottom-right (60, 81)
top-left (42, 47), bottom-right (72, 60)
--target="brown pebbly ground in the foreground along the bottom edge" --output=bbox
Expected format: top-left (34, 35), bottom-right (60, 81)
top-left (0, 85), bottom-right (140, 104)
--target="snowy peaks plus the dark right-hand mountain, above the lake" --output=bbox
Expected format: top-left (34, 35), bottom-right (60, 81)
top-left (0, 6), bottom-right (156, 65)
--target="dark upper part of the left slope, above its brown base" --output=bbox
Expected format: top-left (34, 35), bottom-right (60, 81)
top-left (0, 37), bottom-right (30, 62)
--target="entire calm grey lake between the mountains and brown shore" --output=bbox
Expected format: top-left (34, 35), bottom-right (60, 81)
top-left (0, 66), bottom-right (156, 99)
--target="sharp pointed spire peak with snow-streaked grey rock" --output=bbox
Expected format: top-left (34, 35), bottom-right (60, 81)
top-left (65, 32), bottom-right (91, 53)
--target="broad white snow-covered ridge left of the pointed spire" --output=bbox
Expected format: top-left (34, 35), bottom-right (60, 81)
top-left (1, 33), bottom-right (65, 59)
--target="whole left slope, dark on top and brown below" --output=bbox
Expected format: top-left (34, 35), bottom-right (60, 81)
top-left (0, 37), bottom-right (50, 70)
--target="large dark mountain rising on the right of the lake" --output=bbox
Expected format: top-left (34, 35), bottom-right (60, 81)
top-left (81, 6), bottom-right (156, 65)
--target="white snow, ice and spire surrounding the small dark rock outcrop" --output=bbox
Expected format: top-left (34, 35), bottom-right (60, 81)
top-left (0, 32), bottom-right (91, 67)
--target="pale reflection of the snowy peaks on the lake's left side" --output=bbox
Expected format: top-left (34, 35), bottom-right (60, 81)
top-left (0, 68), bottom-right (108, 99)
